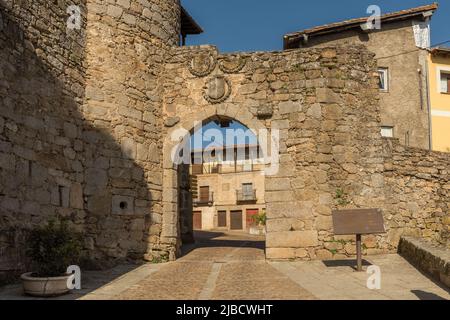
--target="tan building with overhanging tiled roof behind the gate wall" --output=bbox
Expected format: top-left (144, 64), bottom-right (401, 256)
top-left (284, 4), bottom-right (438, 149)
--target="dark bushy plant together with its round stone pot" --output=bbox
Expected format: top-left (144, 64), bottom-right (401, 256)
top-left (21, 220), bottom-right (82, 297)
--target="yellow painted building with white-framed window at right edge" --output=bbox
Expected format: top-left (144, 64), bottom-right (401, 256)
top-left (428, 48), bottom-right (450, 152)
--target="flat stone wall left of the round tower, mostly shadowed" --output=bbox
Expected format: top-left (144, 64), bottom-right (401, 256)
top-left (0, 0), bottom-right (86, 273)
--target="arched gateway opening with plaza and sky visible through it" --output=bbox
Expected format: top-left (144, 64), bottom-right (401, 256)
top-left (177, 116), bottom-right (266, 255)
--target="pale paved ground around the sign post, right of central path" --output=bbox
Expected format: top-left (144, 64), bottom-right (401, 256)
top-left (270, 254), bottom-right (450, 300)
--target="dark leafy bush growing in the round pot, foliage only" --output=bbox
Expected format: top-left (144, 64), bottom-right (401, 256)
top-left (27, 219), bottom-right (82, 277)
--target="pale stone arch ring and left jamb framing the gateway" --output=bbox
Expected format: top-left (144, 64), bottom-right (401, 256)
top-left (160, 104), bottom-right (270, 260)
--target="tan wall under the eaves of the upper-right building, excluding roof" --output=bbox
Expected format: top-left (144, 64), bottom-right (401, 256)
top-left (296, 19), bottom-right (430, 149)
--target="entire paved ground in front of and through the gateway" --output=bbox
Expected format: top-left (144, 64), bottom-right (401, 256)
top-left (0, 232), bottom-right (450, 300)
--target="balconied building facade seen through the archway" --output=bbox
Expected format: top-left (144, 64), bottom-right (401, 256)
top-left (191, 145), bottom-right (265, 230)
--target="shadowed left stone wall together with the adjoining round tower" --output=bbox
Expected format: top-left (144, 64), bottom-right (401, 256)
top-left (0, 0), bottom-right (180, 278)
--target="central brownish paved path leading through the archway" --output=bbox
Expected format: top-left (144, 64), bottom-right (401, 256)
top-left (106, 233), bottom-right (314, 300)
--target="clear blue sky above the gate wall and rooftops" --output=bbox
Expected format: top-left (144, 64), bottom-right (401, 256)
top-left (181, 0), bottom-right (450, 52)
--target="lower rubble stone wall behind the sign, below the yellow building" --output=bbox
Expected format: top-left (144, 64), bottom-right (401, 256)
top-left (384, 139), bottom-right (450, 248)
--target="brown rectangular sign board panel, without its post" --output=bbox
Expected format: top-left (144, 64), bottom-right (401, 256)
top-left (332, 209), bottom-right (386, 235)
